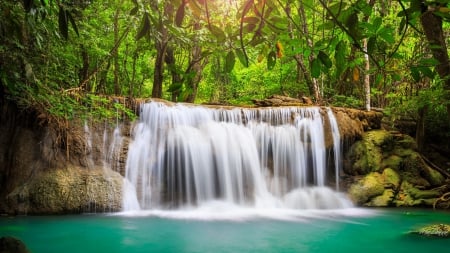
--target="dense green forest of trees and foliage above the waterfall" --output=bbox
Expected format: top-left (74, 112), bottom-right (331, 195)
top-left (0, 0), bottom-right (450, 152)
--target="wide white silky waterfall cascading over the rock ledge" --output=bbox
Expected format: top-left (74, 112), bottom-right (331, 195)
top-left (123, 102), bottom-right (349, 211)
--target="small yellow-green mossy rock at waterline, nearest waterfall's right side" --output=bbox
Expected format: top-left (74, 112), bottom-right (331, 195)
top-left (348, 172), bottom-right (384, 205)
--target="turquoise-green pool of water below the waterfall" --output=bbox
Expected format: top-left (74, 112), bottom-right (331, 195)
top-left (0, 209), bottom-right (450, 253)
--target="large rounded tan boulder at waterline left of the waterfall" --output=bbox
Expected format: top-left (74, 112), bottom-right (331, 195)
top-left (7, 167), bottom-right (123, 214)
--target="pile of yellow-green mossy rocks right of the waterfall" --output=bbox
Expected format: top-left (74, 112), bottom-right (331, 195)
top-left (344, 130), bottom-right (450, 207)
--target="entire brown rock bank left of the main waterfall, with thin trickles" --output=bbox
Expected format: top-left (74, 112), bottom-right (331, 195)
top-left (0, 100), bottom-right (130, 214)
